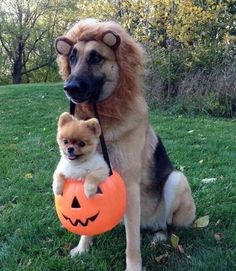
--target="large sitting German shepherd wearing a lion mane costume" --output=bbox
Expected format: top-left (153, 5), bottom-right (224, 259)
top-left (55, 19), bottom-right (195, 271)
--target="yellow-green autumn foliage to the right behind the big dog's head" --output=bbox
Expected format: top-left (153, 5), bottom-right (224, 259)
top-left (79, 0), bottom-right (236, 116)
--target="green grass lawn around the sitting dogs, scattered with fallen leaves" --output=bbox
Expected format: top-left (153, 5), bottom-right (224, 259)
top-left (0, 84), bottom-right (236, 271)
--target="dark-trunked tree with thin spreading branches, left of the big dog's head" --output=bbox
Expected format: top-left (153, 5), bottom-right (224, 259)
top-left (0, 0), bottom-right (76, 84)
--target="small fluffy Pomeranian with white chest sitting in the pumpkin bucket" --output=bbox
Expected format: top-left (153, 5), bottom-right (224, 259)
top-left (53, 112), bottom-right (109, 197)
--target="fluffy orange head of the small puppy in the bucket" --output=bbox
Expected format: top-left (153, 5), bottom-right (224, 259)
top-left (57, 113), bottom-right (101, 160)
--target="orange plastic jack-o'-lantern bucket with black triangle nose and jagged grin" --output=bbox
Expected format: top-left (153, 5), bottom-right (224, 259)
top-left (55, 171), bottom-right (126, 235)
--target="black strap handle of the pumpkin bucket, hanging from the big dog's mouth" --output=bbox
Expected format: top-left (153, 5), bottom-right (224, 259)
top-left (70, 101), bottom-right (112, 176)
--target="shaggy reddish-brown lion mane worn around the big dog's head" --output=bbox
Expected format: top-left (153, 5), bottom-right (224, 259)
top-left (57, 20), bottom-right (143, 119)
